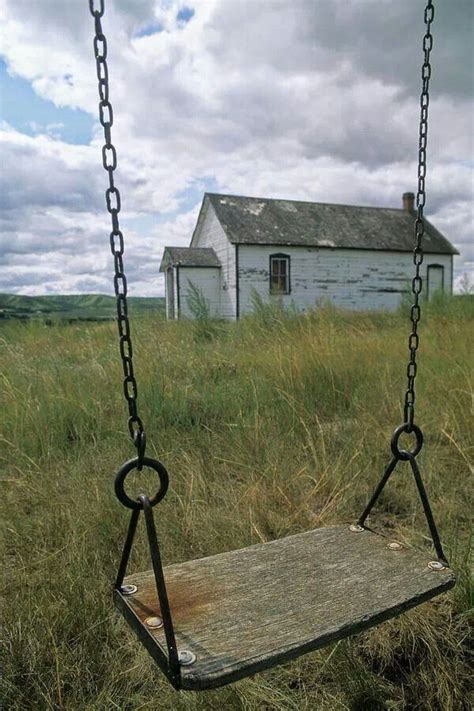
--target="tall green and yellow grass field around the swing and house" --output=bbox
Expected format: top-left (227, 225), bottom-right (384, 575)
top-left (0, 297), bottom-right (474, 711)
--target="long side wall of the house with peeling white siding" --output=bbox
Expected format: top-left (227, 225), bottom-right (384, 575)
top-left (238, 244), bottom-right (453, 315)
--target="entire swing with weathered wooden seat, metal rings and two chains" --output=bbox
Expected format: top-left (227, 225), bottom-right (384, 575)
top-left (89, 0), bottom-right (455, 690)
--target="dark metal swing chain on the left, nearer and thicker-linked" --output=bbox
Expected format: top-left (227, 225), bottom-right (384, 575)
top-left (89, 0), bottom-right (146, 460)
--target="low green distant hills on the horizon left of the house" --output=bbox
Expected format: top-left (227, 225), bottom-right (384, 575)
top-left (0, 294), bottom-right (165, 321)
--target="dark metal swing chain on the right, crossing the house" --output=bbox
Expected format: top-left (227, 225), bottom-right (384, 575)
top-left (404, 0), bottom-right (434, 432)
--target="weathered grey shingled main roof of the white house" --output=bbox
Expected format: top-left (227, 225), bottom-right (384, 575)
top-left (206, 193), bottom-right (459, 254)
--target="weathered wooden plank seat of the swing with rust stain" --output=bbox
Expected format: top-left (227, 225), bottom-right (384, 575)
top-left (115, 525), bottom-right (455, 690)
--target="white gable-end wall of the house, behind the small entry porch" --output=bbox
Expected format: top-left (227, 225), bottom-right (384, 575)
top-left (190, 200), bottom-right (237, 319)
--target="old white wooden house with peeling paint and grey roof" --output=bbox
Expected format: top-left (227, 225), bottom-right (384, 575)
top-left (160, 193), bottom-right (458, 319)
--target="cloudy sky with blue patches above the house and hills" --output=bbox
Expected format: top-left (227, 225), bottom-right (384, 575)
top-left (0, 0), bottom-right (474, 295)
